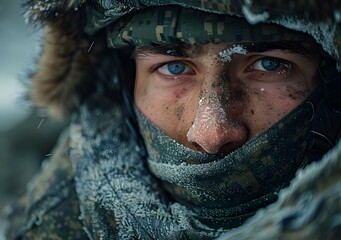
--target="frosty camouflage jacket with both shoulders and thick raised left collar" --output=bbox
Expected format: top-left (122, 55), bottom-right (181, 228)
top-left (1, 93), bottom-right (341, 240)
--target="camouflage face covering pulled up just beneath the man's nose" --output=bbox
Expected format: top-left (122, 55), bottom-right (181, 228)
top-left (135, 102), bottom-right (313, 228)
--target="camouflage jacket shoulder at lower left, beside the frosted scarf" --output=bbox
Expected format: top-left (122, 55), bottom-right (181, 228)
top-left (3, 132), bottom-right (88, 240)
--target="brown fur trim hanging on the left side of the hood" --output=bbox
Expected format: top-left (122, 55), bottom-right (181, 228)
top-left (25, 0), bottom-right (106, 118)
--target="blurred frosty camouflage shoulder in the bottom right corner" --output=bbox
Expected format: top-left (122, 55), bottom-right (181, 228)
top-left (215, 141), bottom-right (341, 240)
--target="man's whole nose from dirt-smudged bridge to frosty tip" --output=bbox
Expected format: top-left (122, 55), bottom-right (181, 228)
top-left (187, 66), bottom-right (246, 154)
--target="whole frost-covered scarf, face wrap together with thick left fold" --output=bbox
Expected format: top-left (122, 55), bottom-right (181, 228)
top-left (71, 94), bottom-right (312, 239)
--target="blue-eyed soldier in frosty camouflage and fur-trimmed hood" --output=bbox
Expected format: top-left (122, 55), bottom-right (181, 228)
top-left (1, 0), bottom-right (341, 239)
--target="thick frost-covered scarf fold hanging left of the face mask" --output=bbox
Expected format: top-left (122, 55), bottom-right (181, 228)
top-left (70, 97), bottom-right (228, 240)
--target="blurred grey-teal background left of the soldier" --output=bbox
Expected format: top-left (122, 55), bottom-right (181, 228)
top-left (0, 0), bottom-right (63, 212)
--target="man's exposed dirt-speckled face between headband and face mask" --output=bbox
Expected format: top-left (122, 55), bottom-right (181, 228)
top-left (135, 43), bottom-right (319, 154)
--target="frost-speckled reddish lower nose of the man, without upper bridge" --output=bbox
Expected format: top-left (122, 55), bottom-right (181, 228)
top-left (187, 92), bottom-right (247, 154)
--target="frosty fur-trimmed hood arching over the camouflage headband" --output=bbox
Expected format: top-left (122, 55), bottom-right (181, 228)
top-left (25, 0), bottom-right (341, 117)
